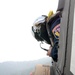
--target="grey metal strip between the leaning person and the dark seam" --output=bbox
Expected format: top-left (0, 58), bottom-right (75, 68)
top-left (56, 0), bottom-right (70, 75)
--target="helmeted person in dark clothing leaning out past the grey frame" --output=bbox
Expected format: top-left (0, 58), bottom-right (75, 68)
top-left (32, 11), bottom-right (61, 62)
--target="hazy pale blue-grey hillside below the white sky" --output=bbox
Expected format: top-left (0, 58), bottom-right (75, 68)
top-left (0, 57), bottom-right (51, 75)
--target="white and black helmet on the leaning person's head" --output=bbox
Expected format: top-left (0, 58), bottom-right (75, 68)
top-left (32, 15), bottom-right (50, 44)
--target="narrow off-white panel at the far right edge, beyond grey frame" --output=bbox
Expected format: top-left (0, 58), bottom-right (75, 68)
top-left (70, 5), bottom-right (75, 74)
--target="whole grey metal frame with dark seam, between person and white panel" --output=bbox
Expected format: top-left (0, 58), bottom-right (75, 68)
top-left (53, 0), bottom-right (75, 75)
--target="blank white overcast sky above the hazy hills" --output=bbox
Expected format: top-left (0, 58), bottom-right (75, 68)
top-left (0, 0), bottom-right (58, 62)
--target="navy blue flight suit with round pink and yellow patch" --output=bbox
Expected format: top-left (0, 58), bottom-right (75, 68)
top-left (50, 18), bottom-right (60, 62)
